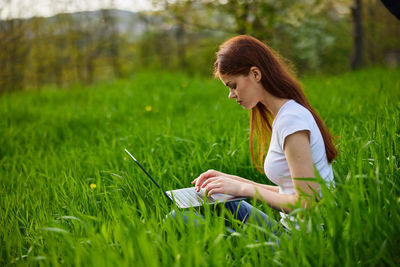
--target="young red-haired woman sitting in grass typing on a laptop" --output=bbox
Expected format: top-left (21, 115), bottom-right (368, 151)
top-left (192, 35), bottom-right (337, 231)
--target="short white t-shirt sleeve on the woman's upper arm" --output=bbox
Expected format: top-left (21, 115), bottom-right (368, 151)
top-left (277, 113), bottom-right (311, 151)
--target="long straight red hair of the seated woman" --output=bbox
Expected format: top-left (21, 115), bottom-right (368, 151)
top-left (214, 35), bottom-right (337, 173)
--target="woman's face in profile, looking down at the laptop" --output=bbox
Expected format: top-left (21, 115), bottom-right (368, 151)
top-left (219, 70), bottom-right (264, 110)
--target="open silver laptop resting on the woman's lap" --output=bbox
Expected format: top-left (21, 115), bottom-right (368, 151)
top-left (125, 148), bottom-right (246, 209)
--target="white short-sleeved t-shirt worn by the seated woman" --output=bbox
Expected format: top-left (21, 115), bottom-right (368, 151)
top-left (264, 99), bottom-right (334, 229)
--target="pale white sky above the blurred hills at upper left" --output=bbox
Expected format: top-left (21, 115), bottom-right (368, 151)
top-left (0, 0), bottom-right (152, 19)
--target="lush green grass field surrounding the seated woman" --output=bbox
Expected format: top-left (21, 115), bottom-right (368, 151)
top-left (0, 69), bottom-right (400, 267)
